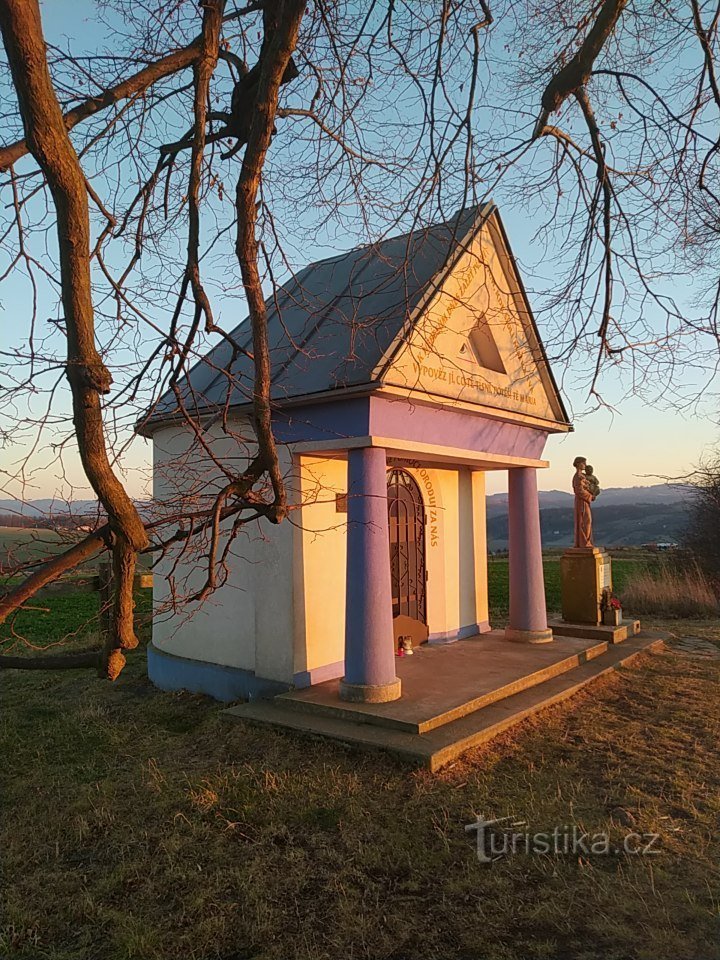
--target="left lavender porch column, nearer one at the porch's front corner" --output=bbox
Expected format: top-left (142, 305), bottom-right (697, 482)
top-left (340, 447), bottom-right (400, 703)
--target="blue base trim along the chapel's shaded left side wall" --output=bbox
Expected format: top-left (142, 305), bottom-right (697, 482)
top-left (147, 643), bottom-right (290, 703)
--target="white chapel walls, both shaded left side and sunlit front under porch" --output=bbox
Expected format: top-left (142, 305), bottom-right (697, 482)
top-left (153, 427), bottom-right (496, 683)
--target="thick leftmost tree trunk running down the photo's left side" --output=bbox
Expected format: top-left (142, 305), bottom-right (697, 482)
top-left (0, 0), bottom-right (148, 679)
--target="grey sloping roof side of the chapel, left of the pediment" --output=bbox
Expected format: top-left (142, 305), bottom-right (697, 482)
top-left (151, 206), bottom-right (490, 421)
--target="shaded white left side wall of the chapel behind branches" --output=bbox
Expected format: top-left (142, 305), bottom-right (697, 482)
top-left (153, 421), bottom-right (292, 682)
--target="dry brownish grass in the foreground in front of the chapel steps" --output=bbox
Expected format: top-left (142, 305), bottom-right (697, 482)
top-left (0, 624), bottom-right (720, 960)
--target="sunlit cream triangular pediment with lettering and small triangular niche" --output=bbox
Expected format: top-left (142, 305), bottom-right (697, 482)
top-left (378, 209), bottom-right (568, 426)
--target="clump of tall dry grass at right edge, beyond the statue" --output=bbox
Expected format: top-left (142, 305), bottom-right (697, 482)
top-left (621, 561), bottom-right (720, 618)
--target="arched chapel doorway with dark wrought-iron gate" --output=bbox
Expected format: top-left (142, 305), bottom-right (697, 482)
top-left (388, 468), bottom-right (428, 646)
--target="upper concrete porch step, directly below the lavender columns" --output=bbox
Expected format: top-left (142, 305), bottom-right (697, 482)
top-left (275, 641), bottom-right (608, 733)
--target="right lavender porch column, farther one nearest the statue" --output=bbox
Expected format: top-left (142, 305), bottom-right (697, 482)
top-left (505, 467), bottom-right (552, 643)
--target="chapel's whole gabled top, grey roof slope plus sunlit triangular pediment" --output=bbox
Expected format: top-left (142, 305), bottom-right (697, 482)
top-left (148, 202), bottom-right (569, 429)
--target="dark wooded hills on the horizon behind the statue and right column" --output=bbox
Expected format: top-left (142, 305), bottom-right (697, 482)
top-left (487, 484), bottom-right (692, 550)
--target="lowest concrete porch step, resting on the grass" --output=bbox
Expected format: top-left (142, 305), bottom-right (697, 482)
top-left (223, 634), bottom-right (664, 770)
